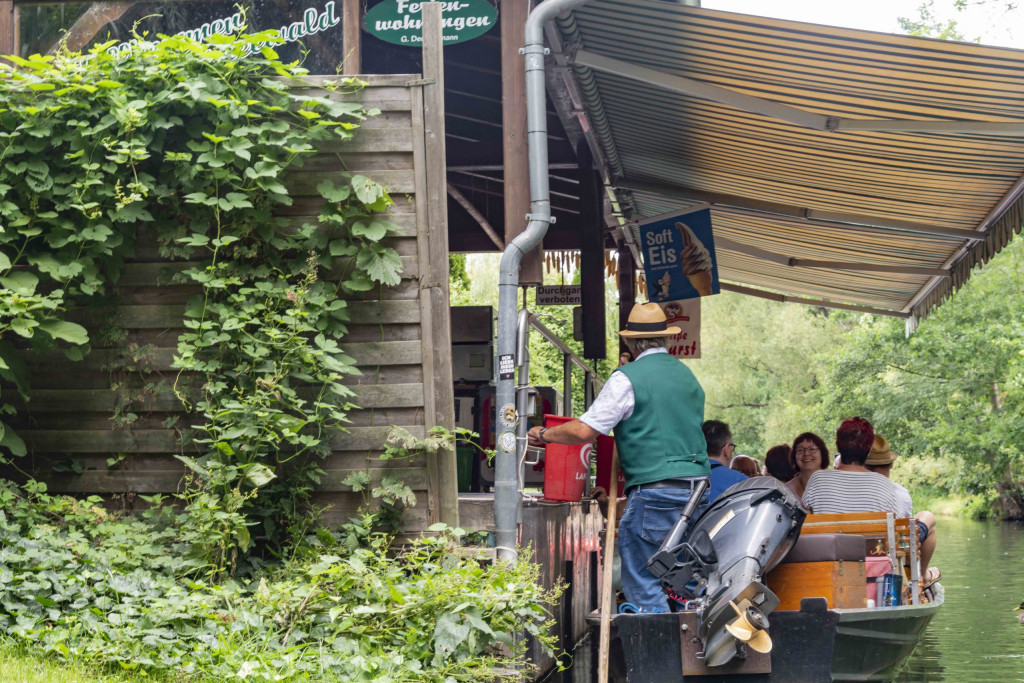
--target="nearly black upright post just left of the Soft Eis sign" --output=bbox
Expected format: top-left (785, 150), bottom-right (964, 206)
top-left (579, 142), bottom-right (607, 359)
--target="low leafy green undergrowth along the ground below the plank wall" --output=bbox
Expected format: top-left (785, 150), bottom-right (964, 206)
top-left (0, 481), bottom-right (556, 682)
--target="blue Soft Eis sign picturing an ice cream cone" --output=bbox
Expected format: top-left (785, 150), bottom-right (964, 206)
top-left (638, 207), bottom-right (719, 303)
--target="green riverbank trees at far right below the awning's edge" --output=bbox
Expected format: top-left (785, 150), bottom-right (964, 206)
top-left (818, 240), bottom-right (1024, 518)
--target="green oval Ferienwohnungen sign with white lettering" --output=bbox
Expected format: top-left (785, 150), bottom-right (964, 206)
top-left (362, 0), bottom-right (498, 47)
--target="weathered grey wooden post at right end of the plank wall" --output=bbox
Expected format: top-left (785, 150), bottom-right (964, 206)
top-left (420, 2), bottom-right (459, 526)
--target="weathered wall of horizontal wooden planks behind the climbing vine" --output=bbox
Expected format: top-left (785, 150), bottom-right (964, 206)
top-left (12, 75), bottom-right (458, 531)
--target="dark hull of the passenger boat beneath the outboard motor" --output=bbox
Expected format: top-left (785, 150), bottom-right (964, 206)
top-left (588, 586), bottom-right (943, 683)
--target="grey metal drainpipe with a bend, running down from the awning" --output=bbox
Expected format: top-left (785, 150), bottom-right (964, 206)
top-left (494, 0), bottom-right (586, 560)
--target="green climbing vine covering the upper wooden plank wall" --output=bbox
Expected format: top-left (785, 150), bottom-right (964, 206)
top-left (0, 33), bottom-right (401, 569)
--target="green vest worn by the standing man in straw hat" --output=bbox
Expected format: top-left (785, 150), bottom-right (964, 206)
top-left (615, 353), bottom-right (711, 486)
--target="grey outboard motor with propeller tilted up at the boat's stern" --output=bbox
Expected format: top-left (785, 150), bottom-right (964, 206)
top-left (647, 477), bottom-right (807, 667)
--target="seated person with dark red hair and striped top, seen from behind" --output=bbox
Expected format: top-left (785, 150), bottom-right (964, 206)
top-left (804, 418), bottom-right (897, 514)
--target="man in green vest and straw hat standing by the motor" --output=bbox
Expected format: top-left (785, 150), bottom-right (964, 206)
top-left (529, 303), bottom-right (710, 612)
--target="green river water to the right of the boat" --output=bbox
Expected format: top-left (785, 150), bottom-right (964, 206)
top-left (897, 519), bottom-right (1024, 682)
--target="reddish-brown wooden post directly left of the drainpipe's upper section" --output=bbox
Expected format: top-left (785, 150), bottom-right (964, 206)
top-left (501, 0), bottom-right (544, 285)
